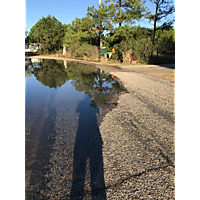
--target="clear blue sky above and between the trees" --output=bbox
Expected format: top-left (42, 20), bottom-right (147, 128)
top-left (25, 0), bottom-right (174, 32)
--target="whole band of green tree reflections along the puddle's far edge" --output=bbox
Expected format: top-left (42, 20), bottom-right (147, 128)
top-left (27, 60), bottom-right (121, 108)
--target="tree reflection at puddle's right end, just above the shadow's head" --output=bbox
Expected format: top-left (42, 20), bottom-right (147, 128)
top-left (66, 62), bottom-right (122, 108)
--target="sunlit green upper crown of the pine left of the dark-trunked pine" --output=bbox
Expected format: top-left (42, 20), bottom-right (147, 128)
top-left (105, 0), bottom-right (146, 26)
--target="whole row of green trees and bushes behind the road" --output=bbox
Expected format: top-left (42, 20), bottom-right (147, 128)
top-left (25, 0), bottom-right (175, 62)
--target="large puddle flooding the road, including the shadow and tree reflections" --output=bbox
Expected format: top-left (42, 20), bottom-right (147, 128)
top-left (25, 59), bottom-right (123, 199)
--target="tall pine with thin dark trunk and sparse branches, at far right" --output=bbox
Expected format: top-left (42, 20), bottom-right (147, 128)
top-left (145, 0), bottom-right (175, 44)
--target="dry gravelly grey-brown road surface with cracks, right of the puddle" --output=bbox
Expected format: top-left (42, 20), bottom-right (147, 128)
top-left (100, 72), bottom-right (175, 199)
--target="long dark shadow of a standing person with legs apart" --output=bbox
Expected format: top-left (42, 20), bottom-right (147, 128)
top-left (71, 95), bottom-right (106, 199)
